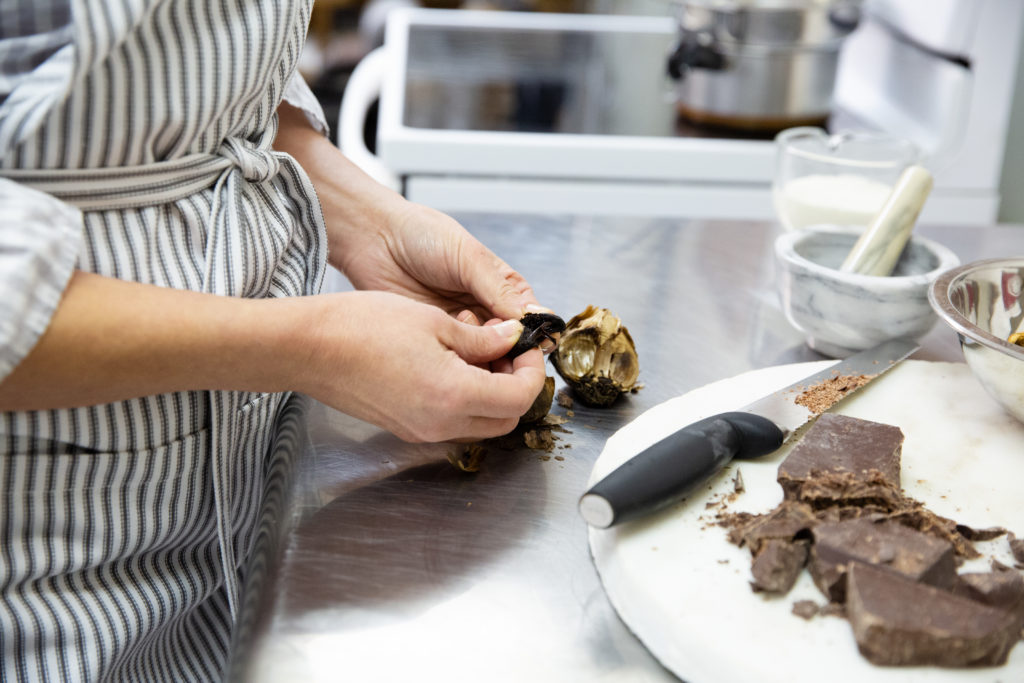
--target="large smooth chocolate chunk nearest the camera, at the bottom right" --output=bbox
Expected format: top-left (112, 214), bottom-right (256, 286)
top-left (846, 563), bottom-right (1020, 667)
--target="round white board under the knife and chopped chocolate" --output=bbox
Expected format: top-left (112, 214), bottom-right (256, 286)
top-left (590, 360), bottom-right (1024, 683)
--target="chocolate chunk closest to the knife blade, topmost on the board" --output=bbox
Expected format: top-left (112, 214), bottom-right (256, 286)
top-left (778, 413), bottom-right (903, 499)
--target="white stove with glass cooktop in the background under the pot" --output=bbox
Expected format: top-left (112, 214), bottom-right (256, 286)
top-left (339, 0), bottom-right (1024, 224)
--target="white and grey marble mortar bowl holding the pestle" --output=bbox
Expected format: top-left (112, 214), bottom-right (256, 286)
top-left (775, 225), bottom-right (959, 358)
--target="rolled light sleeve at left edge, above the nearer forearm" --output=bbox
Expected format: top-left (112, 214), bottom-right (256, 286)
top-left (0, 178), bottom-right (82, 380)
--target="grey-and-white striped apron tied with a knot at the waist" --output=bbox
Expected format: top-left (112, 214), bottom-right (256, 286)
top-left (0, 0), bottom-right (326, 681)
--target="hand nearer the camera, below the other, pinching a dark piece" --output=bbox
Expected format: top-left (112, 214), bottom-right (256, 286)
top-left (298, 292), bottom-right (545, 441)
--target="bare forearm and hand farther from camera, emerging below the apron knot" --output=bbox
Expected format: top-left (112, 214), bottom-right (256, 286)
top-left (274, 103), bottom-right (548, 321)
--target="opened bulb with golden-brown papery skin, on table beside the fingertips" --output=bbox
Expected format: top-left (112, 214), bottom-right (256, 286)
top-left (551, 306), bottom-right (640, 408)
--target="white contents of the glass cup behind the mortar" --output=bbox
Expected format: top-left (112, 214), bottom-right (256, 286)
top-left (773, 174), bottom-right (892, 229)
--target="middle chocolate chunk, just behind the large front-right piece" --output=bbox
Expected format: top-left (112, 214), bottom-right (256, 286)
top-left (809, 519), bottom-right (956, 602)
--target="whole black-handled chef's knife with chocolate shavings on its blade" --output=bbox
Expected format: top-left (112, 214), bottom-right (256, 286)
top-left (580, 340), bottom-right (918, 528)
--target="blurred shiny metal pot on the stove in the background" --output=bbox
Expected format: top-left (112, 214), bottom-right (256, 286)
top-left (668, 0), bottom-right (862, 132)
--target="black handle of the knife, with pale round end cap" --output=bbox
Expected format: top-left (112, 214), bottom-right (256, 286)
top-left (580, 413), bottom-right (785, 528)
